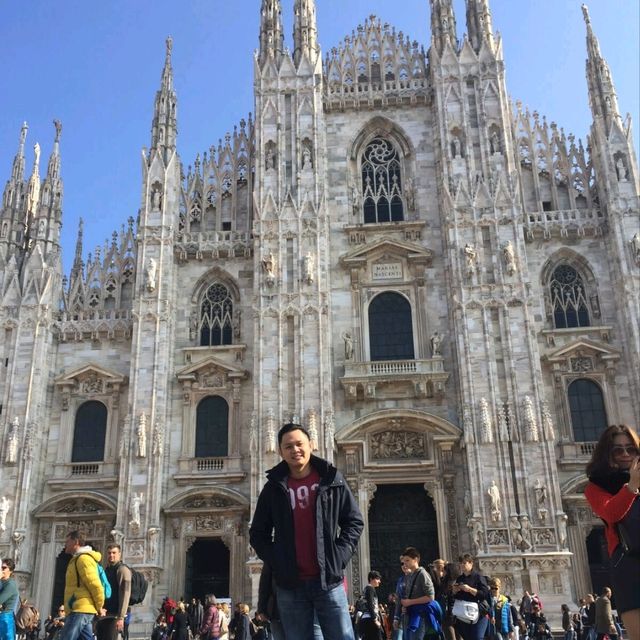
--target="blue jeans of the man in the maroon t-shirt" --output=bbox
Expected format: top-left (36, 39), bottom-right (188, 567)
top-left (276, 580), bottom-right (355, 640)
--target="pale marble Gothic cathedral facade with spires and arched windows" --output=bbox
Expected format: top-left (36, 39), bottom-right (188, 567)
top-left (0, 0), bottom-right (640, 632)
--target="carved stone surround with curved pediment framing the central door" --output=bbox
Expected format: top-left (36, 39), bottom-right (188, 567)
top-left (336, 409), bottom-right (465, 590)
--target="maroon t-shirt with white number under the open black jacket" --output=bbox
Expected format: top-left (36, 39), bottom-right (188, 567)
top-left (287, 469), bottom-right (320, 580)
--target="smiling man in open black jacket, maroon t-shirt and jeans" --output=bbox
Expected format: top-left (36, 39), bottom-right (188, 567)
top-left (250, 423), bottom-right (364, 640)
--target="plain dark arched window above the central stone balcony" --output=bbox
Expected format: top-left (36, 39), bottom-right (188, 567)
top-left (369, 293), bottom-right (415, 360)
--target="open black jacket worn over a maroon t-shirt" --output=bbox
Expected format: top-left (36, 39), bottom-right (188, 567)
top-left (249, 455), bottom-right (364, 589)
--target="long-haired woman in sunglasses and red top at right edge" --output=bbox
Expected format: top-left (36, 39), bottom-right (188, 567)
top-left (584, 425), bottom-right (640, 638)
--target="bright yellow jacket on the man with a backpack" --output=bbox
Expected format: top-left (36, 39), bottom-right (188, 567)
top-left (64, 547), bottom-right (104, 615)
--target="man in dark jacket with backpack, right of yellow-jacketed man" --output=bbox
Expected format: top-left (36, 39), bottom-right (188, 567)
top-left (96, 544), bottom-right (131, 640)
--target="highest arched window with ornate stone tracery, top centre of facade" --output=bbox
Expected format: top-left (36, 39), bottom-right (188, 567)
top-left (362, 138), bottom-right (404, 223)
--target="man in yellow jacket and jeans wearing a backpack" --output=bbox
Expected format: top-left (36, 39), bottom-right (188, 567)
top-left (60, 531), bottom-right (104, 640)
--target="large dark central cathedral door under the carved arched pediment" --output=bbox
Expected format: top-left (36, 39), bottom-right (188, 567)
top-left (362, 484), bottom-right (439, 602)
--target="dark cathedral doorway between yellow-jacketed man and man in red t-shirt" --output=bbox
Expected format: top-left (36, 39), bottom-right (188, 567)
top-left (184, 538), bottom-right (229, 602)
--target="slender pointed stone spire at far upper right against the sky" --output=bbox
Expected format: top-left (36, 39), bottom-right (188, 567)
top-left (582, 4), bottom-right (620, 131)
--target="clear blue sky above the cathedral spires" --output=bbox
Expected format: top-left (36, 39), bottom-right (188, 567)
top-left (0, 0), bottom-right (640, 273)
